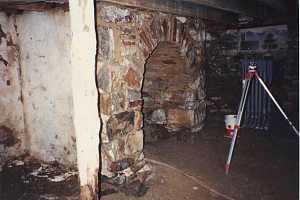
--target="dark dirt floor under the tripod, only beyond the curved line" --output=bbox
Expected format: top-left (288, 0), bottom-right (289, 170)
top-left (145, 115), bottom-right (299, 200)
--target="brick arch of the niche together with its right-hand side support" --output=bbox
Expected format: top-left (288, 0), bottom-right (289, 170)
top-left (138, 14), bottom-right (206, 132)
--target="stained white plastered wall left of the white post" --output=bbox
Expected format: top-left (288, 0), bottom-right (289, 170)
top-left (0, 9), bottom-right (76, 166)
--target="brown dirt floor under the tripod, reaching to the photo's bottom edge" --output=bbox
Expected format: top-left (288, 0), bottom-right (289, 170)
top-left (103, 112), bottom-right (299, 200)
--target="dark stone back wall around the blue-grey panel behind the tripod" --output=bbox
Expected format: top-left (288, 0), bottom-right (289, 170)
top-left (206, 24), bottom-right (299, 130)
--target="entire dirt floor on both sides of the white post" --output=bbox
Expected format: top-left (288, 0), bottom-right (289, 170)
top-left (0, 115), bottom-right (299, 200)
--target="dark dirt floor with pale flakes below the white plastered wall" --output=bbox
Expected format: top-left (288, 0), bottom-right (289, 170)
top-left (0, 155), bottom-right (79, 200)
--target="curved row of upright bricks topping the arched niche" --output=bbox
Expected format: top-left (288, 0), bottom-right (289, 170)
top-left (138, 15), bottom-right (204, 65)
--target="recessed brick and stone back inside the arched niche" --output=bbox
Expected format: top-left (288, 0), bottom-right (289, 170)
top-left (142, 41), bottom-right (203, 143)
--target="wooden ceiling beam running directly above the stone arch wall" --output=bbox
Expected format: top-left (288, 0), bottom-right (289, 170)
top-left (97, 0), bottom-right (238, 23)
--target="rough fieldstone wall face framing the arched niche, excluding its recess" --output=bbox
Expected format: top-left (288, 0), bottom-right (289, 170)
top-left (97, 3), bottom-right (205, 176)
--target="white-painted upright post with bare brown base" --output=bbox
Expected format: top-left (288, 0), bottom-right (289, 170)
top-left (69, 0), bottom-right (100, 200)
